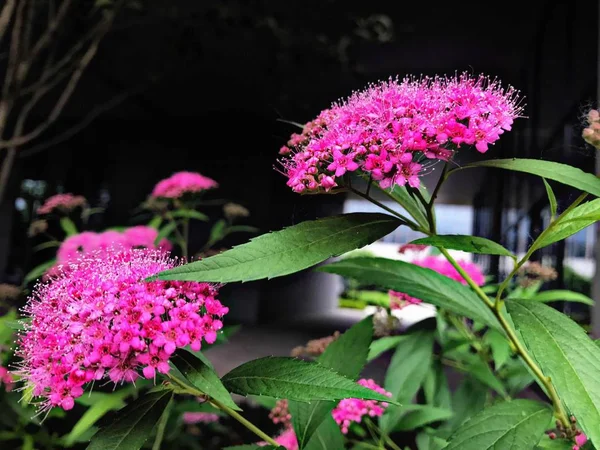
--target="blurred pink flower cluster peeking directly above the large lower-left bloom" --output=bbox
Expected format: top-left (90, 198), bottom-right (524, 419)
top-left (56, 225), bottom-right (172, 264)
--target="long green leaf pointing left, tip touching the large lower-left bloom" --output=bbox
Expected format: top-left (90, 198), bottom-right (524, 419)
top-left (158, 213), bottom-right (401, 283)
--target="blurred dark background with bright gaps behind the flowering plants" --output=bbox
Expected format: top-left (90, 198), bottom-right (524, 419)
top-left (0, 0), bottom-right (600, 369)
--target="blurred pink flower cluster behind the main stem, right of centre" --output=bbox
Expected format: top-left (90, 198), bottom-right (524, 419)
top-left (389, 256), bottom-right (485, 309)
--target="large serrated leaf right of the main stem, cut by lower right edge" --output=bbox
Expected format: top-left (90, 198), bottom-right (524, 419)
top-left (506, 300), bottom-right (600, 447)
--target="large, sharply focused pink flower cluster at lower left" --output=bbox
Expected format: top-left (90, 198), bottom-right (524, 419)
top-left (17, 249), bottom-right (228, 410)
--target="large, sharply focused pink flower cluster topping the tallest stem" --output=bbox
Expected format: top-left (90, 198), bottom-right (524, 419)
top-left (280, 74), bottom-right (522, 193)
